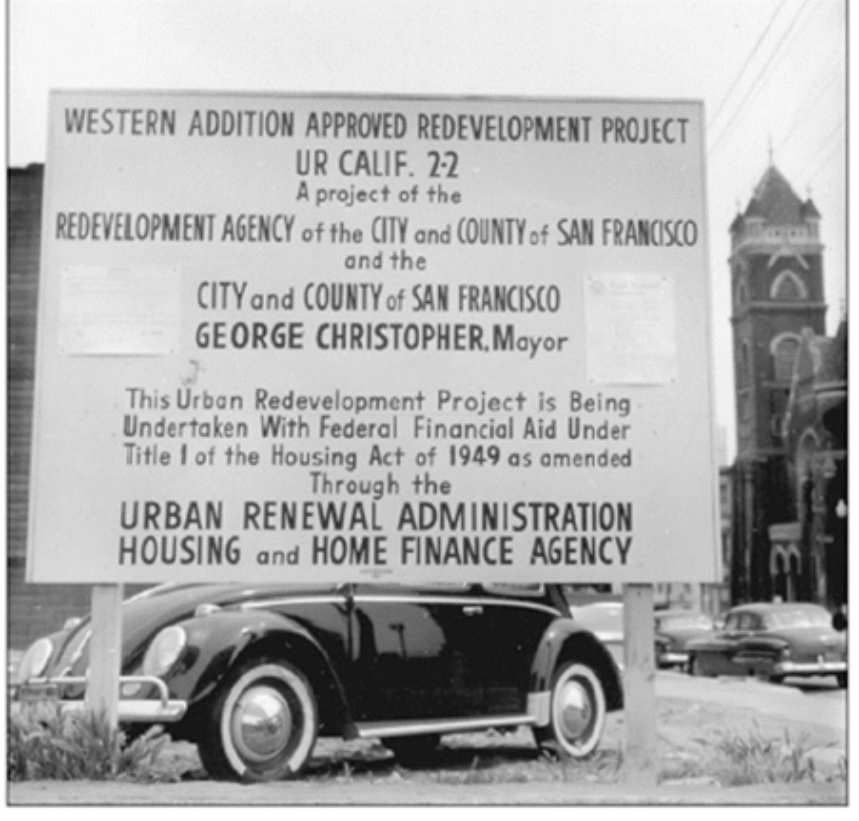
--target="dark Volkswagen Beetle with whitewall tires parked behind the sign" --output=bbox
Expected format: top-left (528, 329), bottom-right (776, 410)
top-left (11, 584), bottom-right (623, 781)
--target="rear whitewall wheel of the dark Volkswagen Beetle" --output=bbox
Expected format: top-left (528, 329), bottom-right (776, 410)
top-left (534, 662), bottom-right (606, 758)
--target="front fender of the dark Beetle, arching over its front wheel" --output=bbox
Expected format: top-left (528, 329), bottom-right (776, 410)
top-left (164, 610), bottom-right (345, 708)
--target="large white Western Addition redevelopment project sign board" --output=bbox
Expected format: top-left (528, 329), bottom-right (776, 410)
top-left (28, 92), bottom-right (717, 583)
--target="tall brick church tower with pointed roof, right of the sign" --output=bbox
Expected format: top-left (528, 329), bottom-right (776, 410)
top-left (729, 164), bottom-right (826, 603)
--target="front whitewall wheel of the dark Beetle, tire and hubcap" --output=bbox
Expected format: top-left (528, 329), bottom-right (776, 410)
top-left (198, 658), bottom-right (319, 781)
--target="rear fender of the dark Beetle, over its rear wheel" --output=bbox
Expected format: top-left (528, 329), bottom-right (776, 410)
top-left (530, 618), bottom-right (623, 710)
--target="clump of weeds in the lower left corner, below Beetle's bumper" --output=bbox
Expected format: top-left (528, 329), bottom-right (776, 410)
top-left (6, 702), bottom-right (178, 783)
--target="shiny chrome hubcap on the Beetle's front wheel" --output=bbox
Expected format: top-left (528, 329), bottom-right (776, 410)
top-left (233, 687), bottom-right (292, 761)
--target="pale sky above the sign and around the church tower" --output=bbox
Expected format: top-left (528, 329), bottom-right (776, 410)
top-left (6, 0), bottom-right (847, 459)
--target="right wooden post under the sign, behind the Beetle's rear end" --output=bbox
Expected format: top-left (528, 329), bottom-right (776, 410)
top-left (623, 584), bottom-right (657, 787)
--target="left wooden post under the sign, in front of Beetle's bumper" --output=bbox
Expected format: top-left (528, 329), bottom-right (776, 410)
top-left (86, 584), bottom-right (123, 729)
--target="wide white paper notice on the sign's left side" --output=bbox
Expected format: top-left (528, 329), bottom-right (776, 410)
top-left (59, 265), bottom-right (181, 356)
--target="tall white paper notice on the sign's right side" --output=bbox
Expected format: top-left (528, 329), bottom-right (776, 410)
top-left (584, 273), bottom-right (677, 385)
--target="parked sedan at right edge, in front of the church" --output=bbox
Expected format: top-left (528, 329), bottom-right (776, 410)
top-left (687, 603), bottom-right (847, 687)
